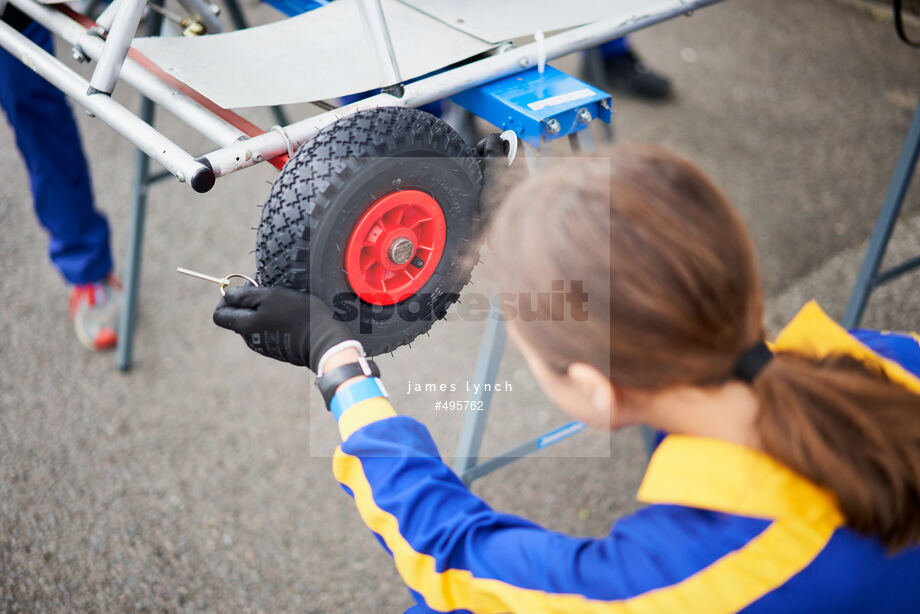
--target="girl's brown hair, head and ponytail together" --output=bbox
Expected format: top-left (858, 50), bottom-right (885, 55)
top-left (491, 145), bottom-right (920, 549)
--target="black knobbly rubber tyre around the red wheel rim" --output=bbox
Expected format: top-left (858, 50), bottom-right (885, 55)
top-left (256, 107), bottom-right (482, 356)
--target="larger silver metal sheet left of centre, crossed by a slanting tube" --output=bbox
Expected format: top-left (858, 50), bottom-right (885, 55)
top-left (134, 0), bottom-right (493, 108)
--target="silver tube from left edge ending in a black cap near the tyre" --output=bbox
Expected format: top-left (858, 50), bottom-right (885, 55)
top-left (0, 21), bottom-right (214, 192)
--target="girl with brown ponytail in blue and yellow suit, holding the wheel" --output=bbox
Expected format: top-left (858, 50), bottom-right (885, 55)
top-left (214, 145), bottom-right (920, 614)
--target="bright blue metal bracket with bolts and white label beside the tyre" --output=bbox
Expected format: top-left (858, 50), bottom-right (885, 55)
top-left (451, 66), bottom-right (612, 147)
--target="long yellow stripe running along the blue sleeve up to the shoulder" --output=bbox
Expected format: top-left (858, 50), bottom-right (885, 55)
top-left (333, 448), bottom-right (839, 614)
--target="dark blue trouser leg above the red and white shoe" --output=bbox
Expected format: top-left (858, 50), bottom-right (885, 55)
top-left (0, 23), bottom-right (112, 284)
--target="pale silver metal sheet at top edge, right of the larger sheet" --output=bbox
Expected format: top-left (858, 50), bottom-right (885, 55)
top-left (400, 0), bottom-right (664, 43)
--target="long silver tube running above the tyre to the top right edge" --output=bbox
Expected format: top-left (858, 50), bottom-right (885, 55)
top-left (203, 0), bottom-right (720, 177)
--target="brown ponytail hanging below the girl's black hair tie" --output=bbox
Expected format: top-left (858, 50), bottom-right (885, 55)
top-left (753, 353), bottom-right (920, 550)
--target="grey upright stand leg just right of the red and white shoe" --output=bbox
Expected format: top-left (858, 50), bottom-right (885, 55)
top-left (116, 0), bottom-right (163, 371)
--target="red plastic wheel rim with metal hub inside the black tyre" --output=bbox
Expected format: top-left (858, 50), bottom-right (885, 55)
top-left (345, 190), bottom-right (447, 305)
